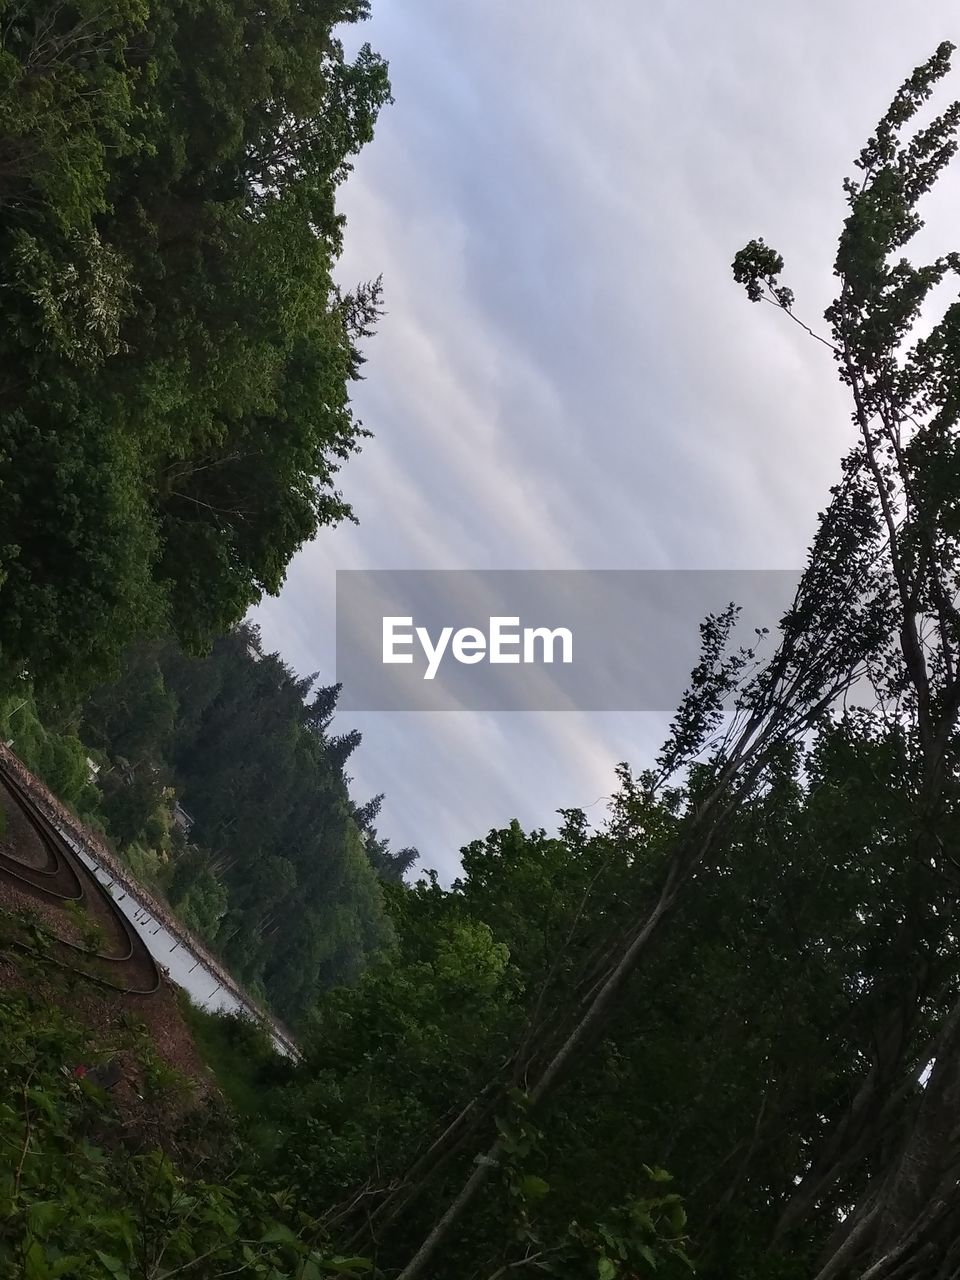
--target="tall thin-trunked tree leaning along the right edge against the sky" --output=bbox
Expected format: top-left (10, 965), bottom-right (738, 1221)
top-left (343, 45), bottom-right (960, 1280)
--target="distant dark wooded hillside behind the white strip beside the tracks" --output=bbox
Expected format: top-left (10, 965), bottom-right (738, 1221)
top-left (0, 626), bottom-right (416, 1024)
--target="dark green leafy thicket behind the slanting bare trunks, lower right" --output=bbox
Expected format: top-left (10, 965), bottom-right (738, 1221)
top-left (264, 712), bottom-right (956, 1280)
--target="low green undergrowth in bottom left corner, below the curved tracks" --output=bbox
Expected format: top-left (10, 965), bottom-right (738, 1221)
top-left (0, 995), bottom-right (381, 1280)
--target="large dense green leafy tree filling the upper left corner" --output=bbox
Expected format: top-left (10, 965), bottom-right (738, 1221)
top-left (0, 0), bottom-right (389, 682)
